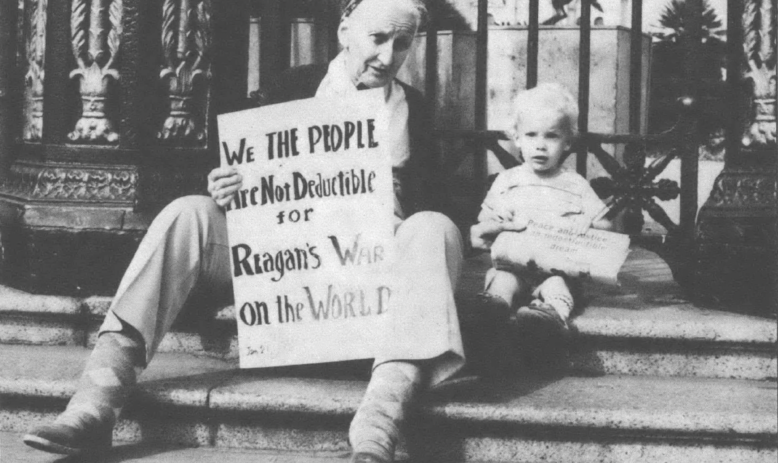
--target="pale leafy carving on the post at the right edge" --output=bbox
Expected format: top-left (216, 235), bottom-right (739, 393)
top-left (742, 0), bottom-right (778, 149)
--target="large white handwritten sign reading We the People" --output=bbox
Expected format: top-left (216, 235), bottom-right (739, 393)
top-left (218, 90), bottom-right (394, 368)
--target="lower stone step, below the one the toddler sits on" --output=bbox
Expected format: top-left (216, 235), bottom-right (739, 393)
top-left (0, 345), bottom-right (778, 463)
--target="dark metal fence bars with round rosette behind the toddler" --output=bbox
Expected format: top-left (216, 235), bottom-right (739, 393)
top-left (425, 0), bottom-right (702, 292)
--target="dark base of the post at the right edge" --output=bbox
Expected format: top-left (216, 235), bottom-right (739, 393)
top-left (695, 159), bottom-right (778, 316)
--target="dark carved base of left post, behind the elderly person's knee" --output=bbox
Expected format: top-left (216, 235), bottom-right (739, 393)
top-left (0, 153), bottom-right (207, 295)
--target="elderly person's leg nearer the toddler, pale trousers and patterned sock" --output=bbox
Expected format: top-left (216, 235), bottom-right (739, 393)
top-left (349, 212), bottom-right (464, 461)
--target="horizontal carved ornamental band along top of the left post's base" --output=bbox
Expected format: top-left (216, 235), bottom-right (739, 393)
top-left (2, 163), bottom-right (138, 202)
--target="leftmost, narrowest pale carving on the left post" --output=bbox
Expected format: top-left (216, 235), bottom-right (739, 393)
top-left (22, 0), bottom-right (47, 141)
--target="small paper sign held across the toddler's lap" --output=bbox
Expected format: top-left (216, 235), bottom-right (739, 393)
top-left (492, 218), bottom-right (629, 285)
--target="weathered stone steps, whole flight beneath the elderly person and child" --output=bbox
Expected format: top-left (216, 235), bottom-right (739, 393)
top-left (0, 249), bottom-right (778, 462)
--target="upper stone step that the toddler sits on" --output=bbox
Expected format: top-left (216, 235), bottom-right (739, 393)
top-left (0, 249), bottom-right (778, 380)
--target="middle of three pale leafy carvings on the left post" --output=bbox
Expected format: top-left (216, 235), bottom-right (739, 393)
top-left (68, 0), bottom-right (122, 143)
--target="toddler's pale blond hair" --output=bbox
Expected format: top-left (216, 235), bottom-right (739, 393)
top-left (508, 82), bottom-right (578, 140)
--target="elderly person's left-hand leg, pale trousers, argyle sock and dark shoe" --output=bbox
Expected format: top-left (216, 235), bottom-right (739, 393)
top-left (24, 196), bottom-right (230, 454)
